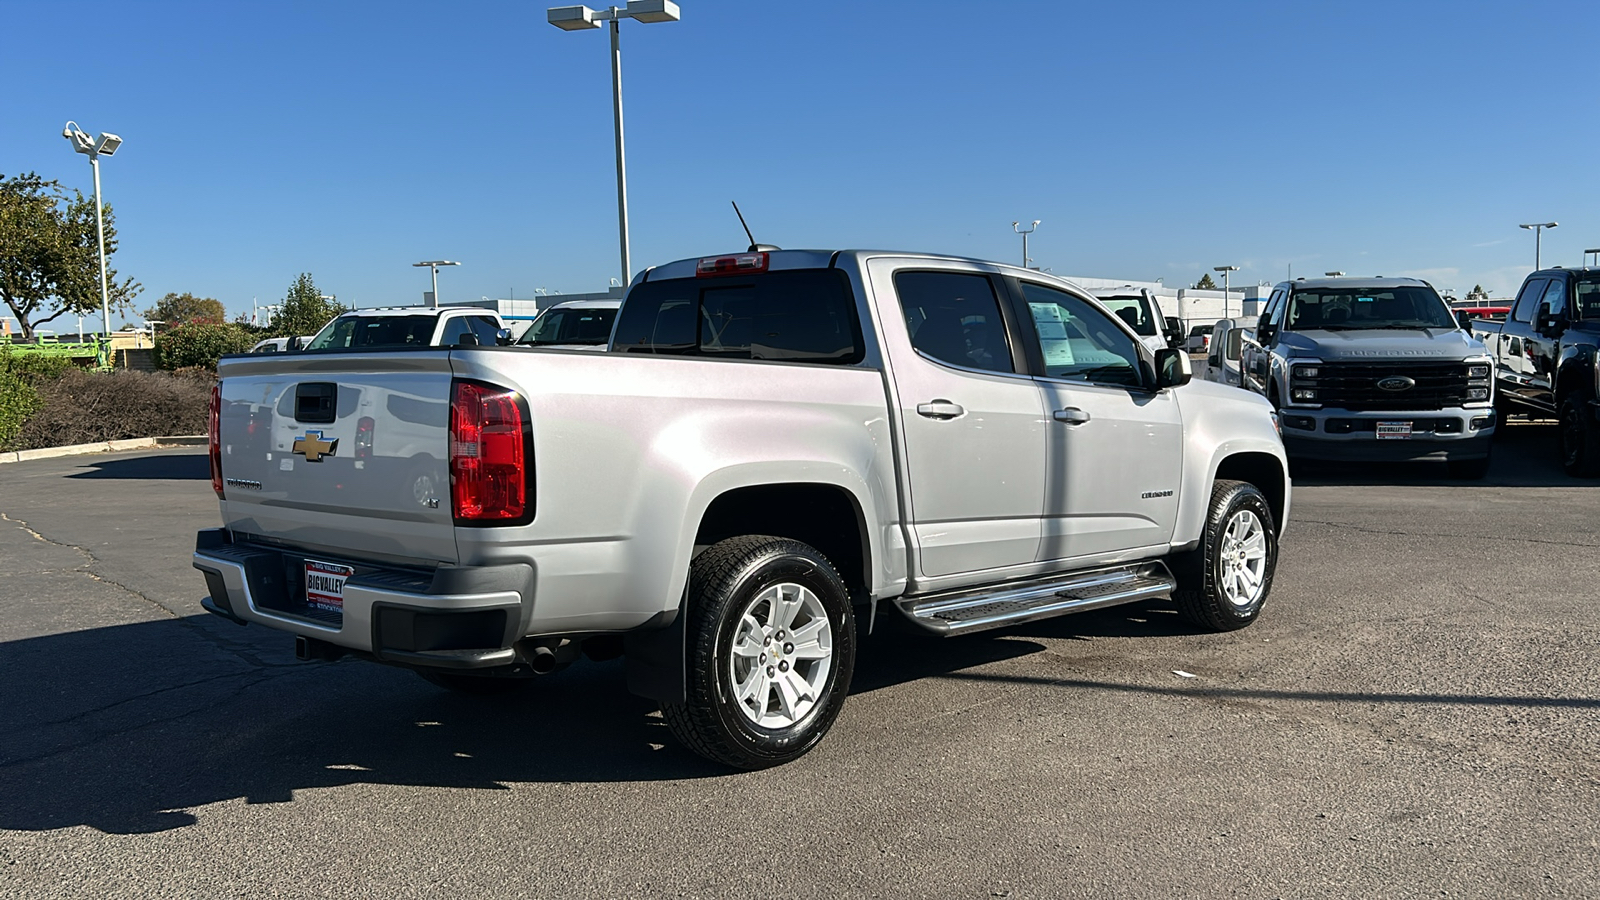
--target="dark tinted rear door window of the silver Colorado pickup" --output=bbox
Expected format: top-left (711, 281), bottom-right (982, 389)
top-left (894, 272), bottom-right (1016, 372)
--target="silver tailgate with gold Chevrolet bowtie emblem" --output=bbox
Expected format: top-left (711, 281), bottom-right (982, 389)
top-left (218, 349), bottom-right (458, 565)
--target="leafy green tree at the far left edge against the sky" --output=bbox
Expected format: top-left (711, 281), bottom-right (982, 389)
top-left (0, 171), bottom-right (144, 340)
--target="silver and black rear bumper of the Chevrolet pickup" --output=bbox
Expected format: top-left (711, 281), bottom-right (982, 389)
top-left (194, 528), bottom-right (534, 669)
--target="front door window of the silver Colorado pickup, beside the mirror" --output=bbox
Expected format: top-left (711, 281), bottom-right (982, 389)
top-left (1022, 282), bottom-right (1144, 388)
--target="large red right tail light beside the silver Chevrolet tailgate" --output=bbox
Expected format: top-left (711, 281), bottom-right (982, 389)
top-left (450, 374), bottom-right (533, 525)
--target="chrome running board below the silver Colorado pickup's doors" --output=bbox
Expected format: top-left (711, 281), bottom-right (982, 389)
top-left (894, 562), bottom-right (1178, 634)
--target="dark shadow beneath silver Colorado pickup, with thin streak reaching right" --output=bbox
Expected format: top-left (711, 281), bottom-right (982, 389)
top-left (9, 605), bottom-right (1600, 834)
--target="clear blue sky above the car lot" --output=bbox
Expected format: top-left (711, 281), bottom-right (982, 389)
top-left (0, 0), bottom-right (1600, 321)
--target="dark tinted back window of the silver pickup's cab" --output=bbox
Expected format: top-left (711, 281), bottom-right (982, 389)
top-left (611, 269), bottom-right (866, 365)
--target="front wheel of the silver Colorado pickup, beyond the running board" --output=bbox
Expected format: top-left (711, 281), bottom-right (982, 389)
top-left (1173, 479), bottom-right (1278, 631)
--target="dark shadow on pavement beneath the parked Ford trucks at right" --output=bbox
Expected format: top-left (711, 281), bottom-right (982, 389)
top-left (1291, 420), bottom-right (1600, 487)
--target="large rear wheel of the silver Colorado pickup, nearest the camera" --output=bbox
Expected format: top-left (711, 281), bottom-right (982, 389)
top-left (661, 535), bottom-right (856, 769)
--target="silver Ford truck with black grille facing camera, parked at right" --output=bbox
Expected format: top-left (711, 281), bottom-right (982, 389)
top-left (1240, 277), bottom-right (1496, 479)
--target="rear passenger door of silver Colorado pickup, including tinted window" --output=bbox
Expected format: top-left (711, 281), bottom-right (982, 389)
top-left (867, 259), bottom-right (1045, 578)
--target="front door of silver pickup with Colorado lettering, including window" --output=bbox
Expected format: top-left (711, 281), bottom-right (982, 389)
top-left (1021, 282), bottom-right (1182, 560)
